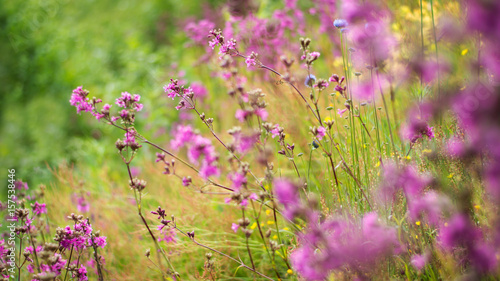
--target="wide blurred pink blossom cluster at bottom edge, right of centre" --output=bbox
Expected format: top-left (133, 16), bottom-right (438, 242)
top-left (290, 213), bottom-right (401, 280)
